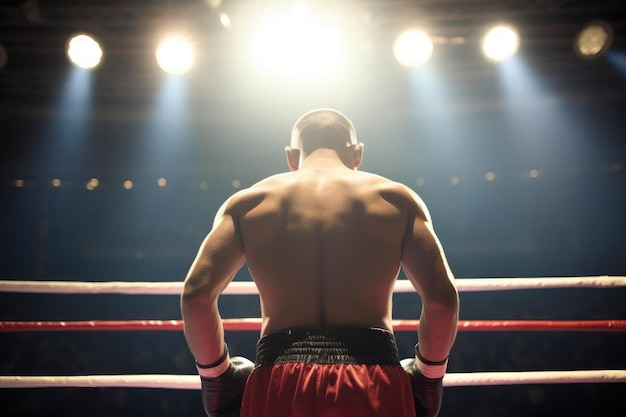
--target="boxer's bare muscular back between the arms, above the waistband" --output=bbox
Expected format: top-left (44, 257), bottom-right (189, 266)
top-left (228, 168), bottom-right (410, 334)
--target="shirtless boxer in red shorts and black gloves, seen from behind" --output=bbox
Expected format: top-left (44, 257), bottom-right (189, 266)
top-left (181, 109), bottom-right (459, 417)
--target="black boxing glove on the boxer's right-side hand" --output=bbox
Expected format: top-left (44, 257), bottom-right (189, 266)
top-left (400, 346), bottom-right (447, 417)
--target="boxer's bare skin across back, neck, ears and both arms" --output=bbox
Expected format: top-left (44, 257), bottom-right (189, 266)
top-left (181, 110), bottom-right (459, 364)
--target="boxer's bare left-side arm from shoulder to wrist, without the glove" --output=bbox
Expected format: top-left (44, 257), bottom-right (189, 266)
top-left (181, 199), bottom-right (244, 365)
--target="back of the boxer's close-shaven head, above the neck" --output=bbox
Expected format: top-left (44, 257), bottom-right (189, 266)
top-left (291, 109), bottom-right (357, 155)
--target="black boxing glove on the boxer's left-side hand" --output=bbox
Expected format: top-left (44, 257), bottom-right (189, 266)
top-left (200, 356), bottom-right (254, 417)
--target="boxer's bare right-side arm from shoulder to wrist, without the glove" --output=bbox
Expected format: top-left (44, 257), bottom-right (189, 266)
top-left (402, 191), bottom-right (459, 362)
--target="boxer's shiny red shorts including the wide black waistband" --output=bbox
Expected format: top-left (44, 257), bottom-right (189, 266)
top-left (241, 328), bottom-right (415, 417)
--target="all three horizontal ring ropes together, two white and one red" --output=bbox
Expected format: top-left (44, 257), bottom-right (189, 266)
top-left (0, 276), bottom-right (626, 390)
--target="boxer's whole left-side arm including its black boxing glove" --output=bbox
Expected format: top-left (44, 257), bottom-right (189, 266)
top-left (181, 199), bottom-right (254, 417)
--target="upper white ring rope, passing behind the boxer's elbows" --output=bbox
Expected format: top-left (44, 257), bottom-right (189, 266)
top-left (0, 275), bottom-right (626, 295)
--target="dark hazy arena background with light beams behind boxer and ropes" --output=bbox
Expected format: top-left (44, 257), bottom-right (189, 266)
top-left (0, 0), bottom-right (626, 417)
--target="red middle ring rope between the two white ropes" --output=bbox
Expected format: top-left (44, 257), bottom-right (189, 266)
top-left (0, 318), bottom-right (626, 333)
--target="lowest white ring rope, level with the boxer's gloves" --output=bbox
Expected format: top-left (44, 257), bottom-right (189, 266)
top-left (0, 370), bottom-right (626, 390)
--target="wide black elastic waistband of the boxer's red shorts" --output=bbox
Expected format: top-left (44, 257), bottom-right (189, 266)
top-left (255, 328), bottom-right (400, 367)
